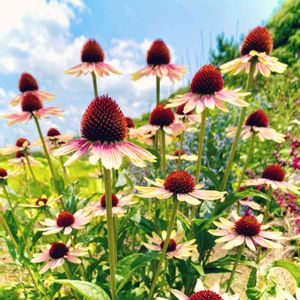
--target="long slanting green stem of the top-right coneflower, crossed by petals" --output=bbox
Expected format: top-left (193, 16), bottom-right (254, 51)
top-left (221, 62), bottom-right (256, 191)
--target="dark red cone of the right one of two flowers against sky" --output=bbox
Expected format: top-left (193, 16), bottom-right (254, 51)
top-left (147, 39), bottom-right (171, 66)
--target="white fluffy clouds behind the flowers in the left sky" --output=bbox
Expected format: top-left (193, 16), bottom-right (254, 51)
top-left (0, 0), bottom-right (186, 144)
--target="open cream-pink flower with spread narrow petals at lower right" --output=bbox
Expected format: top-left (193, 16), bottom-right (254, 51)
top-left (209, 212), bottom-right (282, 251)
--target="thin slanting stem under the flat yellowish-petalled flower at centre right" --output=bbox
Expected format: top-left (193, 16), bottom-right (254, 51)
top-left (147, 196), bottom-right (178, 300)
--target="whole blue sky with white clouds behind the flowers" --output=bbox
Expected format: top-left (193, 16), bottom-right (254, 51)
top-left (0, 0), bottom-right (281, 147)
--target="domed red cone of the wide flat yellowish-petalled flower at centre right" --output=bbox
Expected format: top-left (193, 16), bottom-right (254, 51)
top-left (164, 171), bottom-right (195, 194)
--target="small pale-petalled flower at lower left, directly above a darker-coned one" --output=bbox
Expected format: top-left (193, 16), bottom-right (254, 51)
top-left (39, 209), bottom-right (92, 235)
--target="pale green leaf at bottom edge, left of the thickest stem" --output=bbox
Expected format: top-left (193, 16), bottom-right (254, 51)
top-left (53, 279), bottom-right (110, 300)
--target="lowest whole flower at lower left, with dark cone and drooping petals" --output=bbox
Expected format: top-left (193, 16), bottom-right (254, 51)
top-left (31, 241), bottom-right (87, 273)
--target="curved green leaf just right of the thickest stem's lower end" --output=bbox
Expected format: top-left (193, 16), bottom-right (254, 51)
top-left (117, 252), bottom-right (159, 292)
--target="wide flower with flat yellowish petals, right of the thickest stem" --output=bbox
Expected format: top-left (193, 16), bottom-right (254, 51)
top-left (136, 170), bottom-right (225, 205)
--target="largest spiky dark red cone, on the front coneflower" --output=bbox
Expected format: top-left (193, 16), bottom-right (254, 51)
top-left (81, 96), bottom-right (127, 143)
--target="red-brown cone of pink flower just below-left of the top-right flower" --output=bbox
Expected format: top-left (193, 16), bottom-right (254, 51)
top-left (190, 64), bottom-right (224, 95)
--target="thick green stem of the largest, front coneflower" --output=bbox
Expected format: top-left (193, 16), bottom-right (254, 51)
top-left (103, 168), bottom-right (117, 300)
